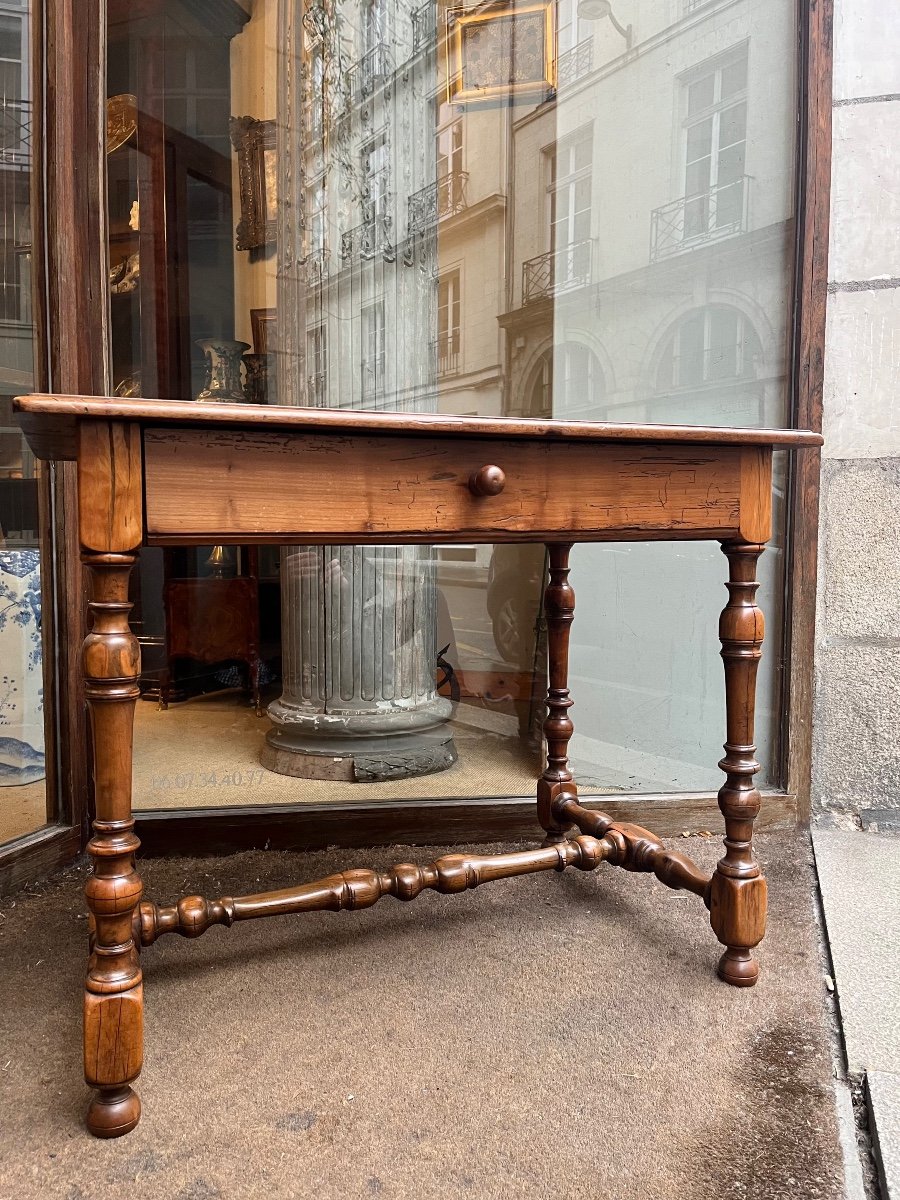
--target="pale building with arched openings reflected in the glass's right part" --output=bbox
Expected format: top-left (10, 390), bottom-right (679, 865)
top-left (500, 2), bottom-right (792, 425)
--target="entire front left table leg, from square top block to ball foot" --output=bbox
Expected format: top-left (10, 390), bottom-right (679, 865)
top-left (78, 421), bottom-right (144, 1138)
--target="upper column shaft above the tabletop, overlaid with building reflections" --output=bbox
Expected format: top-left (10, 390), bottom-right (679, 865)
top-left (280, 0), bottom-right (439, 410)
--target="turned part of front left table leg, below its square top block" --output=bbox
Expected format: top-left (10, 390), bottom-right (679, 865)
top-left (83, 553), bottom-right (144, 1138)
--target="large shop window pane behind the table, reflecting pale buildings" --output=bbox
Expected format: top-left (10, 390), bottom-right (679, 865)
top-left (107, 0), bottom-right (798, 808)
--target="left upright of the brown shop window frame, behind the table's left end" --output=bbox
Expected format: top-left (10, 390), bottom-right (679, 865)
top-left (0, 0), bottom-right (109, 894)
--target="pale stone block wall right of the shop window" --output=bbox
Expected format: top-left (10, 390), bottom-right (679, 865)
top-left (812, 0), bottom-right (900, 821)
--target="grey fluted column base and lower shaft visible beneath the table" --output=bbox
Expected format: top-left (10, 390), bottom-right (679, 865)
top-left (264, 546), bottom-right (456, 780)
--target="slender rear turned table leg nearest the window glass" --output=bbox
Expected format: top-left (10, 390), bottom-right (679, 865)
top-left (538, 542), bottom-right (576, 846)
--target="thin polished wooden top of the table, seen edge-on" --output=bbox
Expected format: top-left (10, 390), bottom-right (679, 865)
top-left (13, 394), bottom-right (822, 458)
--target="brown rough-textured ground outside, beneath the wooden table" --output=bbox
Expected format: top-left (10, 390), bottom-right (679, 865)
top-left (0, 835), bottom-right (841, 1200)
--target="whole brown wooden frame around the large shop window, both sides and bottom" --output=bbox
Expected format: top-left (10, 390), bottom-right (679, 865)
top-left (0, 0), bottom-right (833, 890)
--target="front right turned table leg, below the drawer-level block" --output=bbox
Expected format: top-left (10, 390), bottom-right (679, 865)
top-left (709, 541), bottom-right (766, 988)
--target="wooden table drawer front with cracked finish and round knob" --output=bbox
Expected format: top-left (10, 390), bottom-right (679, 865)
top-left (144, 428), bottom-right (770, 544)
